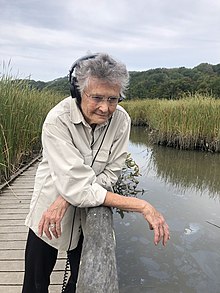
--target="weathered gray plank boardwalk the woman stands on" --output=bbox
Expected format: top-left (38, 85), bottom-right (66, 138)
top-left (0, 163), bottom-right (65, 293)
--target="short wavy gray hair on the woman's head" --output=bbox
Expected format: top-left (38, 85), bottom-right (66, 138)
top-left (75, 53), bottom-right (129, 96)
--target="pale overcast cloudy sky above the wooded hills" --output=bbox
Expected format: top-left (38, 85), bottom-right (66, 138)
top-left (0, 0), bottom-right (220, 81)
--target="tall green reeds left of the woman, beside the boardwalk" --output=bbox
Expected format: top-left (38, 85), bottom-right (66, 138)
top-left (0, 74), bottom-right (62, 182)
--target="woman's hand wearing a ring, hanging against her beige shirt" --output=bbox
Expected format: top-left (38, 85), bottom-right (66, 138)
top-left (38, 196), bottom-right (70, 240)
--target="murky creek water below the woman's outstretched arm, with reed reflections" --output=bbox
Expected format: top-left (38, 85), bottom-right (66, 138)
top-left (114, 127), bottom-right (220, 293)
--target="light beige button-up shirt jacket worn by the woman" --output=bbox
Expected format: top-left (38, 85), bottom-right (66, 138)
top-left (25, 97), bottom-right (130, 251)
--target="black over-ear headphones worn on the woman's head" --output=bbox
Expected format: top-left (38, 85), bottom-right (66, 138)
top-left (69, 54), bottom-right (124, 104)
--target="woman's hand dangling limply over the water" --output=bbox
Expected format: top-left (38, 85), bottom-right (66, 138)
top-left (142, 202), bottom-right (170, 246)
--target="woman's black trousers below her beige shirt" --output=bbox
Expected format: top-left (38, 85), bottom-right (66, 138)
top-left (22, 229), bottom-right (83, 293)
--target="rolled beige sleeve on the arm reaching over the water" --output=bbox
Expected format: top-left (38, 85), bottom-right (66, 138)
top-left (42, 121), bottom-right (107, 207)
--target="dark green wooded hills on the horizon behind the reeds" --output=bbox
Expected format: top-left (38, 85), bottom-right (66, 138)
top-left (24, 63), bottom-right (220, 99)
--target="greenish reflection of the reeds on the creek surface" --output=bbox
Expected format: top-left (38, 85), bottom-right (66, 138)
top-left (130, 127), bottom-right (220, 197)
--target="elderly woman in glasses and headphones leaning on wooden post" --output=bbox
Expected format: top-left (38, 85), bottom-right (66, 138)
top-left (22, 53), bottom-right (169, 293)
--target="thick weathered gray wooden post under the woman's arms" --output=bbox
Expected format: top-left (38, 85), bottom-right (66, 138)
top-left (76, 206), bottom-right (119, 293)
